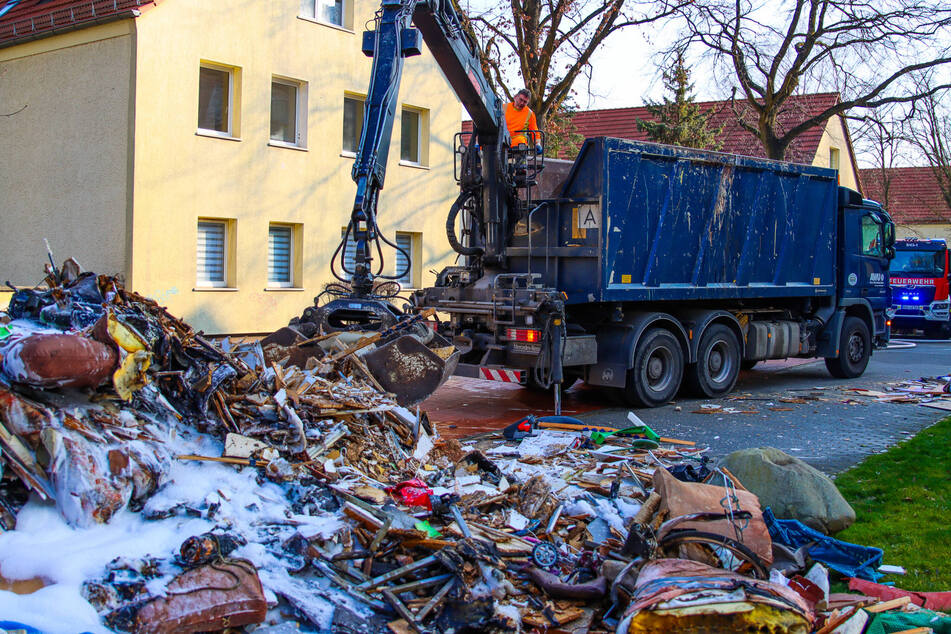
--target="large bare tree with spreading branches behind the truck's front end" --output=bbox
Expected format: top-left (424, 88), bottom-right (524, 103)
top-left (671, 0), bottom-right (951, 159)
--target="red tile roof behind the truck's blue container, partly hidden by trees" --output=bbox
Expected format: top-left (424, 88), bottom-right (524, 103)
top-left (572, 93), bottom-right (839, 164)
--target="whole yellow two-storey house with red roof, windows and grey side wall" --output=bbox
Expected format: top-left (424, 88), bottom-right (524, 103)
top-left (0, 0), bottom-right (460, 333)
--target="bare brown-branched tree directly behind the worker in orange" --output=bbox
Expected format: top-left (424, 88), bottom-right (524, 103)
top-left (468, 0), bottom-right (694, 127)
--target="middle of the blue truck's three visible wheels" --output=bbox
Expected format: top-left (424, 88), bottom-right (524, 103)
top-left (684, 324), bottom-right (740, 398)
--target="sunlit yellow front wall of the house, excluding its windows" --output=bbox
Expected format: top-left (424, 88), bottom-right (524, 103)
top-left (132, 0), bottom-right (460, 333)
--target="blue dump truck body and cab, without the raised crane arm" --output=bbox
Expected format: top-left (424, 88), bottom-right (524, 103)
top-left (414, 138), bottom-right (895, 407)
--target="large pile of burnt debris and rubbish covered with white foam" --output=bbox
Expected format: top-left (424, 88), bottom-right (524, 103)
top-left (0, 262), bottom-right (943, 634)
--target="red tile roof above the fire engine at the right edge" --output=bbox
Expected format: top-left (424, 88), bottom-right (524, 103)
top-left (859, 167), bottom-right (951, 224)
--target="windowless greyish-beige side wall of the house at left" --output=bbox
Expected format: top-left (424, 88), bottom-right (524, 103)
top-left (0, 20), bottom-right (134, 286)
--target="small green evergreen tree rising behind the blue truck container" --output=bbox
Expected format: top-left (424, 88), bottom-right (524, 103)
top-left (637, 52), bottom-right (723, 150)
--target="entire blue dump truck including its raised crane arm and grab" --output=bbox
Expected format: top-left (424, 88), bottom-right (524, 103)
top-left (304, 0), bottom-right (895, 412)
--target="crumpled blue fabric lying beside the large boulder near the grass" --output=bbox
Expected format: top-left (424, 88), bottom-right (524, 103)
top-left (763, 508), bottom-right (883, 581)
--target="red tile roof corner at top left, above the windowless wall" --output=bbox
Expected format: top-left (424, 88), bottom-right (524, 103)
top-left (0, 0), bottom-right (156, 47)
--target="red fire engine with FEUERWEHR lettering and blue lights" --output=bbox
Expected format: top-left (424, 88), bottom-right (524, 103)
top-left (890, 238), bottom-right (951, 339)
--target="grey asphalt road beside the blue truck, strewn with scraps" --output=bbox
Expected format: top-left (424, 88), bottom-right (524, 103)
top-left (578, 341), bottom-right (951, 474)
